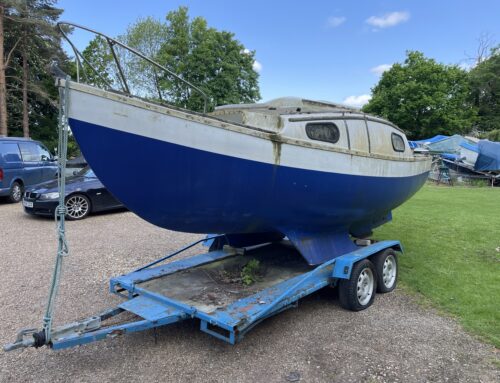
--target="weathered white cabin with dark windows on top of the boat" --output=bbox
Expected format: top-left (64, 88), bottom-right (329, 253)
top-left (210, 97), bottom-right (413, 159)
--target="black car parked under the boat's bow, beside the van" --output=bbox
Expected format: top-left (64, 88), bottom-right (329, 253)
top-left (23, 167), bottom-right (124, 220)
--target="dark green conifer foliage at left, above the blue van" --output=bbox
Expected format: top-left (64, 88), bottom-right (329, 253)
top-left (4, 0), bottom-right (69, 150)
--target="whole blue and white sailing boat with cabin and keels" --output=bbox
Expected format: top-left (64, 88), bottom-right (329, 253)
top-left (58, 22), bottom-right (431, 264)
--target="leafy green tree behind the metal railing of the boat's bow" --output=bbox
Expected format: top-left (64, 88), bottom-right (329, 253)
top-left (79, 7), bottom-right (260, 111)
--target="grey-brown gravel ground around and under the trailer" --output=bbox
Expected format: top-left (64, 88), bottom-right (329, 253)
top-left (0, 203), bottom-right (500, 382)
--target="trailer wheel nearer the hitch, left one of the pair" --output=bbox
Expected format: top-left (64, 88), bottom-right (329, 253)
top-left (339, 259), bottom-right (377, 311)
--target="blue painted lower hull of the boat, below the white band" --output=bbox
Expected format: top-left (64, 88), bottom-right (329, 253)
top-left (70, 119), bottom-right (427, 238)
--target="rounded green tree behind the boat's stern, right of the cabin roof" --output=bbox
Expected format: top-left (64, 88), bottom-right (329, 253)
top-left (363, 51), bottom-right (476, 139)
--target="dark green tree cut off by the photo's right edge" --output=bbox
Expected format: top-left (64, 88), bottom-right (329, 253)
top-left (469, 46), bottom-right (500, 132)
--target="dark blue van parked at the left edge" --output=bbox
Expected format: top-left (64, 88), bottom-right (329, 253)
top-left (0, 137), bottom-right (57, 202)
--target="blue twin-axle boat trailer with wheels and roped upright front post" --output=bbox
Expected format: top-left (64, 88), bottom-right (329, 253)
top-left (4, 73), bottom-right (403, 351)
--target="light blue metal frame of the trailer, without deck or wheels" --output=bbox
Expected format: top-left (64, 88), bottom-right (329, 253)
top-left (5, 241), bottom-right (403, 350)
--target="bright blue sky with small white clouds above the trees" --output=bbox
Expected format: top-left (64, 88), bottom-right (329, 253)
top-left (57, 0), bottom-right (500, 107)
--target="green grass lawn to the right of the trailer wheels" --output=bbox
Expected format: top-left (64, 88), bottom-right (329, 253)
top-left (375, 185), bottom-right (500, 347)
